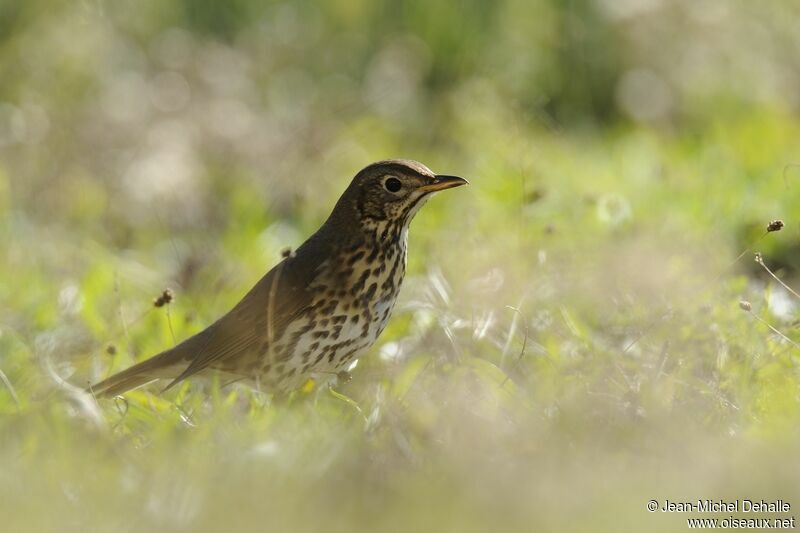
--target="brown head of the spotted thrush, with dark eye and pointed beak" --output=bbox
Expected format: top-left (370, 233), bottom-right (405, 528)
top-left (334, 159), bottom-right (467, 233)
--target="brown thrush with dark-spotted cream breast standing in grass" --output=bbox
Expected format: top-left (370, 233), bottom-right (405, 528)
top-left (87, 159), bottom-right (468, 397)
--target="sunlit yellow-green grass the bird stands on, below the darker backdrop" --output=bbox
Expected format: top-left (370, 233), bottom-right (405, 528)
top-left (0, 110), bottom-right (800, 531)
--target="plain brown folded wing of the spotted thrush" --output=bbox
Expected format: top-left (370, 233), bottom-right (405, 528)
top-left (164, 250), bottom-right (320, 391)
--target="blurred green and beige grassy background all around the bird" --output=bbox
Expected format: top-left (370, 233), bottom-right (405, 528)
top-left (0, 0), bottom-right (800, 531)
